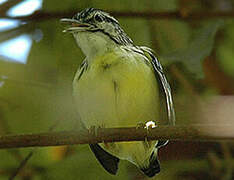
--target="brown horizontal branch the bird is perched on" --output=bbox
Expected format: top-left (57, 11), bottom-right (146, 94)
top-left (0, 125), bottom-right (234, 149)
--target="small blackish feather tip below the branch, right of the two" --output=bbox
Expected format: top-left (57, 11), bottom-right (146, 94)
top-left (141, 152), bottom-right (160, 177)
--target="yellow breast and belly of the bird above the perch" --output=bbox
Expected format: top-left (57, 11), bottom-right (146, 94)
top-left (73, 48), bottom-right (159, 127)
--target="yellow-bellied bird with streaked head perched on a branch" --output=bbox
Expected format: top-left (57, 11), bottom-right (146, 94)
top-left (60, 8), bottom-right (175, 177)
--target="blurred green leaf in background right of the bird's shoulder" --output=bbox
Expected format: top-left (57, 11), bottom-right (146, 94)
top-left (161, 20), bottom-right (224, 78)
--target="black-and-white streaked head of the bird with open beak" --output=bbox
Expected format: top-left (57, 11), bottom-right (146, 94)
top-left (61, 8), bottom-right (132, 50)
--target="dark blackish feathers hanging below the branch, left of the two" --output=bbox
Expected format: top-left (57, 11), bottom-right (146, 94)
top-left (89, 144), bottom-right (119, 175)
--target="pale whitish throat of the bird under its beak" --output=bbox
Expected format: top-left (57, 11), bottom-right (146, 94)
top-left (73, 32), bottom-right (118, 61)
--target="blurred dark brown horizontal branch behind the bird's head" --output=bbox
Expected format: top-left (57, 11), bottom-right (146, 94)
top-left (1, 9), bottom-right (234, 21)
